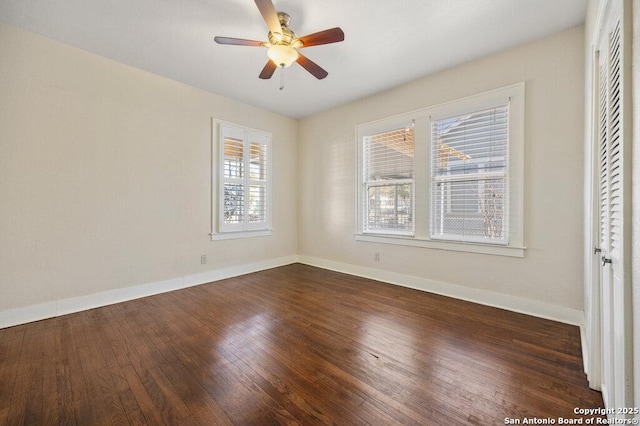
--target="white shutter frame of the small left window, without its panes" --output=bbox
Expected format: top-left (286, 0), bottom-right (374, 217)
top-left (211, 119), bottom-right (273, 240)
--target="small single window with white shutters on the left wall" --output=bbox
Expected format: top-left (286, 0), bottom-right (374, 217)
top-left (212, 123), bottom-right (271, 239)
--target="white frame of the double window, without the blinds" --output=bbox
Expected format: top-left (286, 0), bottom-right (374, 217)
top-left (355, 82), bottom-right (525, 257)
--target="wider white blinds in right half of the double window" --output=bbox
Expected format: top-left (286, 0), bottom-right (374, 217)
top-left (430, 101), bottom-right (509, 244)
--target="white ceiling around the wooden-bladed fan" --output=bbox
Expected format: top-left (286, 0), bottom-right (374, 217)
top-left (0, 0), bottom-right (586, 118)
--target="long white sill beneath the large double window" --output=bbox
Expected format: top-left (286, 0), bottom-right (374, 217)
top-left (355, 234), bottom-right (526, 257)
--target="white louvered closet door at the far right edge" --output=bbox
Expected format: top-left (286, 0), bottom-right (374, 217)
top-left (597, 1), bottom-right (633, 408)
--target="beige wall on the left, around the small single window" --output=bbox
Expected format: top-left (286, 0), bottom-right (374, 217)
top-left (0, 25), bottom-right (297, 312)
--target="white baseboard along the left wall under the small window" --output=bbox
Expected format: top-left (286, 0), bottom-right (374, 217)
top-left (0, 256), bottom-right (298, 328)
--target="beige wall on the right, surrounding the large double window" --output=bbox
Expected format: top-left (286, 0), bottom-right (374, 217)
top-left (298, 26), bottom-right (584, 311)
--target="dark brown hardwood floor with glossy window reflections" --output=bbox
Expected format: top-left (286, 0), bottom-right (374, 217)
top-left (0, 264), bottom-right (603, 425)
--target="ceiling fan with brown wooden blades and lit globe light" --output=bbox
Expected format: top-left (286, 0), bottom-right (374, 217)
top-left (214, 0), bottom-right (344, 80)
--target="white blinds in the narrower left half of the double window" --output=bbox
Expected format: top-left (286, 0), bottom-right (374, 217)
top-left (362, 123), bottom-right (414, 235)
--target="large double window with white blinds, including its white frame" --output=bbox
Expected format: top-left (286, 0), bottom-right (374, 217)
top-left (356, 83), bottom-right (524, 257)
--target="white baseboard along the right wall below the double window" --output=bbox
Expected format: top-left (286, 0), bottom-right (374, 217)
top-left (298, 256), bottom-right (584, 326)
